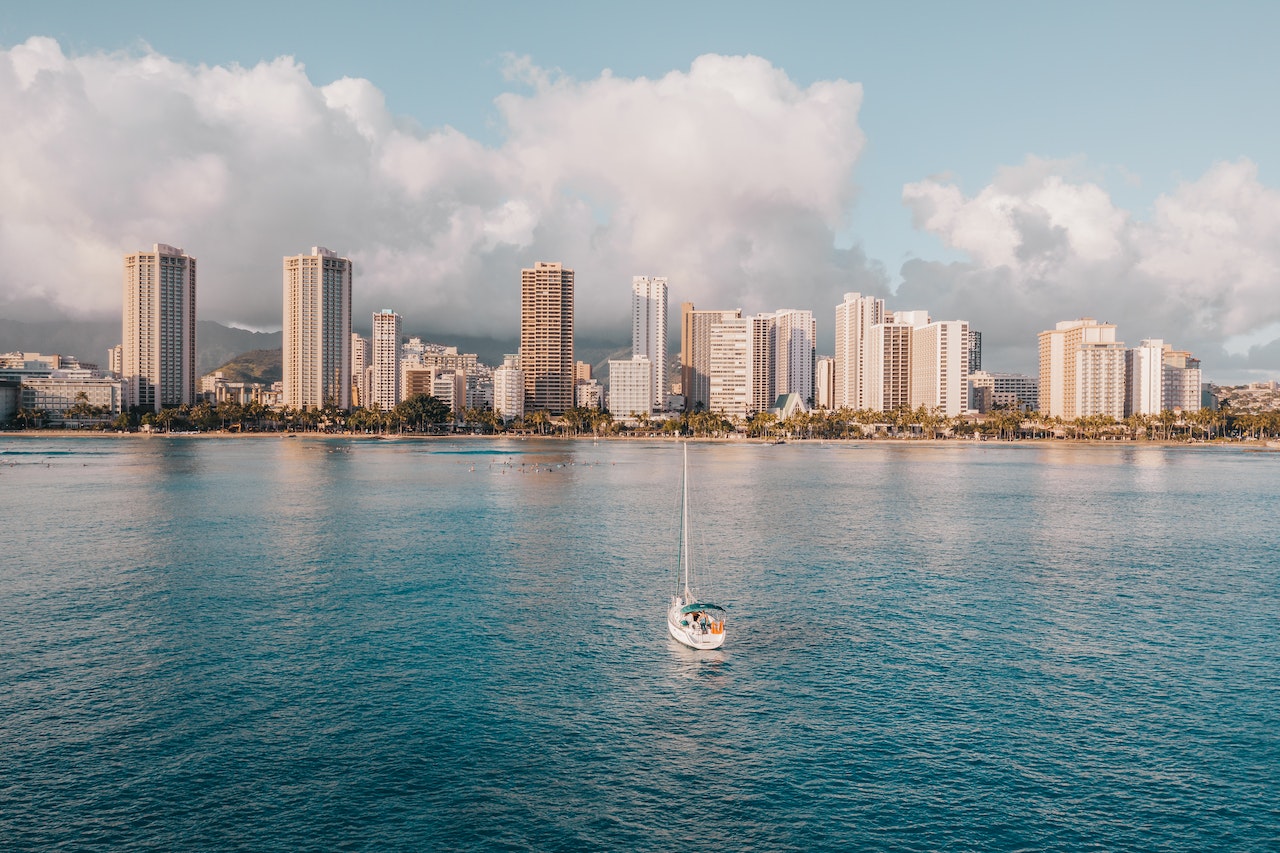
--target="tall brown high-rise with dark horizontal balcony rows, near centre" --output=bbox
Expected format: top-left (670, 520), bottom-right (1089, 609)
top-left (520, 261), bottom-right (573, 415)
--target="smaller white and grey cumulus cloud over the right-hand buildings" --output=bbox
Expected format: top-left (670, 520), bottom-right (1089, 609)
top-left (896, 158), bottom-right (1280, 375)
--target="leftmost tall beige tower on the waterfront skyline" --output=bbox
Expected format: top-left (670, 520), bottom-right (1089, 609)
top-left (120, 243), bottom-right (196, 411)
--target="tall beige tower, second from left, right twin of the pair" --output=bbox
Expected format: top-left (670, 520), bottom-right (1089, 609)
top-left (282, 246), bottom-right (352, 409)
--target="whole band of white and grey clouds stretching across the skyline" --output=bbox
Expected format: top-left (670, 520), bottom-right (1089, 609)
top-left (0, 37), bottom-right (1280, 378)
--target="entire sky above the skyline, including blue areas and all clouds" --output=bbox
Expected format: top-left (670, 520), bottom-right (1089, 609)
top-left (0, 0), bottom-right (1280, 384)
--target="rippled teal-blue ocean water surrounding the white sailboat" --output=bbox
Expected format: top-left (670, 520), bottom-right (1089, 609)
top-left (0, 437), bottom-right (1280, 850)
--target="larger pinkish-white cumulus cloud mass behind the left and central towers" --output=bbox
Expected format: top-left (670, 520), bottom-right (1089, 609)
top-left (0, 37), bottom-right (886, 337)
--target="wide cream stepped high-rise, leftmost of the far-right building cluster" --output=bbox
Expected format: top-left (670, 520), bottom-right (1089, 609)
top-left (1039, 316), bottom-right (1124, 420)
